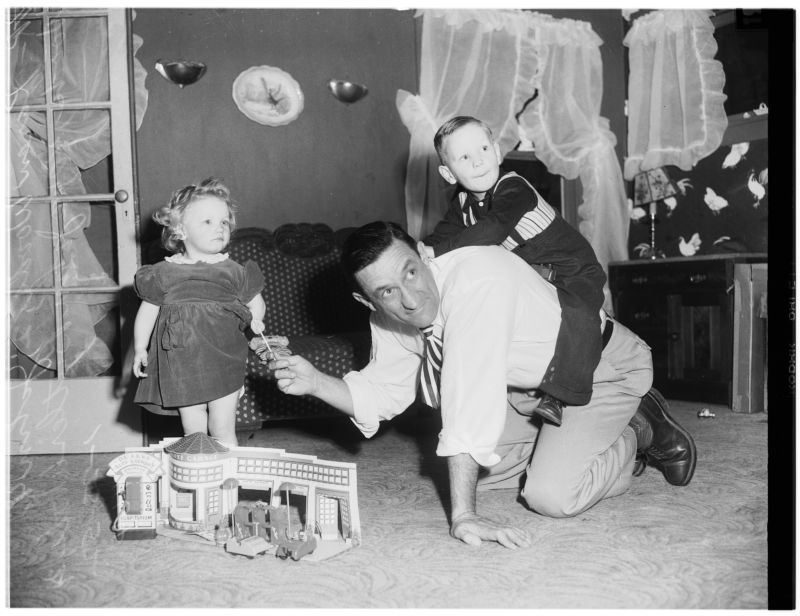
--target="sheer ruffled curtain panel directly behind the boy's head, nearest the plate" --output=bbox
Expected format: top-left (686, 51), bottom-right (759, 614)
top-left (397, 10), bottom-right (538, 237)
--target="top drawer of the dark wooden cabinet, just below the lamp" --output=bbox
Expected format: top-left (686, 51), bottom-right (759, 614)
top-left (609, 261), bottom-right (732, 292)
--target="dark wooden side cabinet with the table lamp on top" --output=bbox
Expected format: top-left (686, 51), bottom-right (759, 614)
top-left (609, 253), bottom-right (767, 412)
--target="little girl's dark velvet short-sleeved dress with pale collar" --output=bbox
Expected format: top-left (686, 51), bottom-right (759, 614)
top-left (134, 259), bottom-right (264, 415)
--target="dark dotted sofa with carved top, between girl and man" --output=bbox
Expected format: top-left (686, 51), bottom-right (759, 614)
top-left (229, 223), bottom-right (370, 429)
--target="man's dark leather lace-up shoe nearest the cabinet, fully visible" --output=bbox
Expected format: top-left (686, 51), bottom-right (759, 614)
top-left (630, 389), bottom-right (697, 486)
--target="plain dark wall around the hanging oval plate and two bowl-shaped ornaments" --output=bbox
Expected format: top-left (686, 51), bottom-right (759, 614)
top-left (133, 9), bottom-right (421, 239)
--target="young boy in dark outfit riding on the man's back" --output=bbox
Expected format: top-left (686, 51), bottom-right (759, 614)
top-left (423, 116), bottom-right (610, 425)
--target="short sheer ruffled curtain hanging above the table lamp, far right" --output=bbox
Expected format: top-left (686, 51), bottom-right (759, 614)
top-left (624, 10), bottom-right (728, 180)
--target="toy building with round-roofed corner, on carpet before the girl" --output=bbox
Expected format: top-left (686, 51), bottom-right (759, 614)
top-left (107, 432), bottom-right (361, 560)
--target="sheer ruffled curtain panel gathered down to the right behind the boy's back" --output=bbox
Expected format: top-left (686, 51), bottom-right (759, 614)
top-left (519, 19), bottom-right (628, 310)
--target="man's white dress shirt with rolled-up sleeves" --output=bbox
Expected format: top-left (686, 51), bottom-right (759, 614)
top-left (344, 246), bottom-right (561, 466)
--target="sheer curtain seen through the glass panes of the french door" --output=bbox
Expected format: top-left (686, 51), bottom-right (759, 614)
top-left (7, 19), bottom-right (147, 376)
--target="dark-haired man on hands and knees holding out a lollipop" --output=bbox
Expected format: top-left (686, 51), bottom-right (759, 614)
top-left (270, 222), bottom-right (697, 548)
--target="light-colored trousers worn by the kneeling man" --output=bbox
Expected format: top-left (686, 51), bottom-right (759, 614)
top-left (478, 321), bottom-right (653, 518)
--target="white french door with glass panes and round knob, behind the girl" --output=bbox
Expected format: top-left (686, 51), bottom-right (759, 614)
top-left (7, 9), bottom-right (142, 454)
